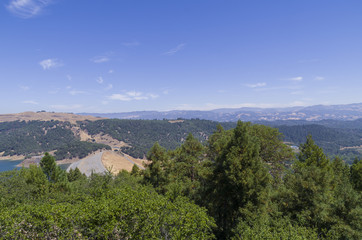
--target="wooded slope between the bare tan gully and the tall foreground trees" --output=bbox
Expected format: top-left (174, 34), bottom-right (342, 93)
top-left (81, 119), bottom-right (235, 158)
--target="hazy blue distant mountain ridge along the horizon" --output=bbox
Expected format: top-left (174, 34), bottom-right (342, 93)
top-left (79, 103), bottom-right (362, 122)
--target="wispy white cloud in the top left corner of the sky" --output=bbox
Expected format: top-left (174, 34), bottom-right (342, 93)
top-left (6, 0), bottom-right (52, 18)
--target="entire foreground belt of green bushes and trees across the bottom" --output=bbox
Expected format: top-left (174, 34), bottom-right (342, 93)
top-left (0, 122), bottom-right (362, 240)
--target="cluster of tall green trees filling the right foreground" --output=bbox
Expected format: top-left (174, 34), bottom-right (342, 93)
top-left (143, 122), bottom-right (362, 239)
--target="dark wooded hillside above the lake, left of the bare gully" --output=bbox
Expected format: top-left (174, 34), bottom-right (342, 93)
top-left (0, 121), bottom-right (111, 160)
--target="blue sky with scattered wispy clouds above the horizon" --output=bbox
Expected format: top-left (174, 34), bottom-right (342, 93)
top-left (0, 0), bottom-right (362, 113)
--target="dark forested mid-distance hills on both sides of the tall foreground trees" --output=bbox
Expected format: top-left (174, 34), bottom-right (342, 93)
top-left (0, 119), bottom-right (362, 164)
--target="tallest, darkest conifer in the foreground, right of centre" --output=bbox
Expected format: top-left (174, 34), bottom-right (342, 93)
top-left (209, 121), bottom-right (270, 239)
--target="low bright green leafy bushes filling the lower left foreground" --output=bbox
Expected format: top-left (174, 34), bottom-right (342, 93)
top-left (0, 166), bottom-right (215, 239)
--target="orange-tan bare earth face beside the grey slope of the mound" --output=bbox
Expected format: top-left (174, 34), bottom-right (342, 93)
top-left (102, 151), bottom-right (147, 174)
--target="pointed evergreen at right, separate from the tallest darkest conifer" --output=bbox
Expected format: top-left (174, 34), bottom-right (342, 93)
top-left (280, 136), bottom-right (333, 232)
